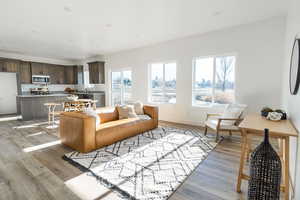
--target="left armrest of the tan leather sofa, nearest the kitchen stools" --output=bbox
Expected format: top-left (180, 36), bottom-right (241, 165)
top-left (60, 112), bottom-right (96, 153)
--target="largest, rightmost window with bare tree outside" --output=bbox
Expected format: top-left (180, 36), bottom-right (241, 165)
top-left (192, 56), bottom-right (235, 106)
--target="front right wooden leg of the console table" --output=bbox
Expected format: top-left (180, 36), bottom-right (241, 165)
top-left (283, 137), bottom-right (290, 200)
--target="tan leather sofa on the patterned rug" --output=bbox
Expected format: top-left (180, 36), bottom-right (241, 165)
top-left (60, 105), bottom-right (158, 153)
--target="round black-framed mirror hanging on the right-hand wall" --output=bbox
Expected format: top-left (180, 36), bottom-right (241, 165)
top-left (289, 38), bottom-right (300, 95)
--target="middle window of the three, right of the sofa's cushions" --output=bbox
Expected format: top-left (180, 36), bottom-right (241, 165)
top-left (150, 63), bottom-right (176, 103)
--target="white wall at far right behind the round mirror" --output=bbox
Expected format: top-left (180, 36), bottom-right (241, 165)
top-left (282, 0), bottom-right (300, 199)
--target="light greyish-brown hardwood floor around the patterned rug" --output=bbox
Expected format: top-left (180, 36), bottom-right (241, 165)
top-left (0, 118), bottom-right (272, 200)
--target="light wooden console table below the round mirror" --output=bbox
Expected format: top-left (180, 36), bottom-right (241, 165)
top-left (236, 114), bottom-right (298, 200)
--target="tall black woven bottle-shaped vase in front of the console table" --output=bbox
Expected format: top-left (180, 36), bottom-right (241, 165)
top-left (248, 129), bottom-right (281, 200)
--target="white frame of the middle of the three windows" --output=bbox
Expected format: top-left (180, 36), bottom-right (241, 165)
top-left (148, 60), bottom-right (178, 105)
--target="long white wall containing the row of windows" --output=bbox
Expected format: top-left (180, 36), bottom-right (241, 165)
top-left (105, 17), bottom-right (285, 124)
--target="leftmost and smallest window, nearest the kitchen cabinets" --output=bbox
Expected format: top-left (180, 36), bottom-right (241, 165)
top-left (111, 70), bottom-right (132, 105)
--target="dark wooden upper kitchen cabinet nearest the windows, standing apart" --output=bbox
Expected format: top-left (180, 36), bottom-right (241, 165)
top-left (88, 61), bottom-right (105, 84)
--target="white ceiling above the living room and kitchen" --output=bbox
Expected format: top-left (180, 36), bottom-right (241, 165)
top-left (0, 0), bottom-right (288, 59)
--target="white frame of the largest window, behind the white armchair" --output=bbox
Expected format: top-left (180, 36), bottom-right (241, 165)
top-left (192, 53), bottom-right (237, 107)
